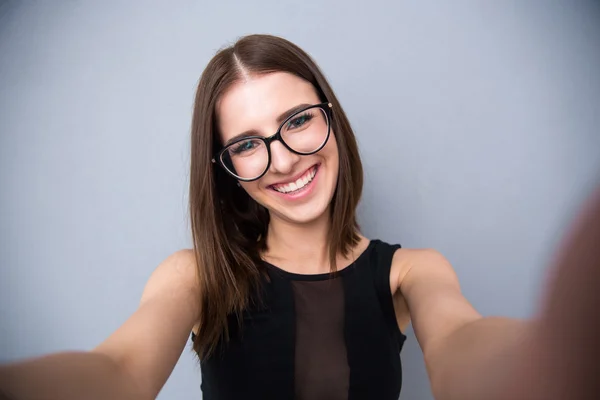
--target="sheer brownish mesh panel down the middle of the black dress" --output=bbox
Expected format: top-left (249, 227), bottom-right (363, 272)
top-left (292, 278), bottom-right (350, 400)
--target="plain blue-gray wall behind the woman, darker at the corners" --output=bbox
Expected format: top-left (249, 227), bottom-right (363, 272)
top-left (0, 0), bottom-right (600, 400)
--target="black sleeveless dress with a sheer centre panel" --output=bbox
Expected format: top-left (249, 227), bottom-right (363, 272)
top-left (195, 240), bottom-right (406, 400)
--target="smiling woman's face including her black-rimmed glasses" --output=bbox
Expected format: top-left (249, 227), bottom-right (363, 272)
top-left (216, 71), bottom-right (340, 225)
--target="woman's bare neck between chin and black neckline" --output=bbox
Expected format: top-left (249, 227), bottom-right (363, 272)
top-left (264, 212), bottom-right (330, 273)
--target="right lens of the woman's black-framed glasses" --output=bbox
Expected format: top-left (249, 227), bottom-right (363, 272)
top-left (281, 107), bottom-right (329, 154)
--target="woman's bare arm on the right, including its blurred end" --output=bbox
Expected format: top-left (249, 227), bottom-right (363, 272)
top-left (393, 188), bottom-right (600, 400)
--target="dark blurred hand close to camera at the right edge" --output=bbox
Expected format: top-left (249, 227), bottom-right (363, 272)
top-left (507, 184), bottom-right (600, 400)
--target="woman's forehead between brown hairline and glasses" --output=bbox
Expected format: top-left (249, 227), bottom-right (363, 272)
top-left (217, 72), bottom-right (319, 141)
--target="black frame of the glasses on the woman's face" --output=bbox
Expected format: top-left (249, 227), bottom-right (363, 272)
top-left (211, 102), bottom-right (333, 182)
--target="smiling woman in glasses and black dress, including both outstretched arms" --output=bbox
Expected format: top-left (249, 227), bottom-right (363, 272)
top-left (1, 35), bottom-right (600, 400)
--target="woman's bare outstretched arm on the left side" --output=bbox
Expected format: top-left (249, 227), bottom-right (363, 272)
top-left (0, 251), bottom-right (198, 400)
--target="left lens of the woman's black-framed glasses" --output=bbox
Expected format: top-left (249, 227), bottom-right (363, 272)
top-left (221, 139), bottom-right (269, 179)
